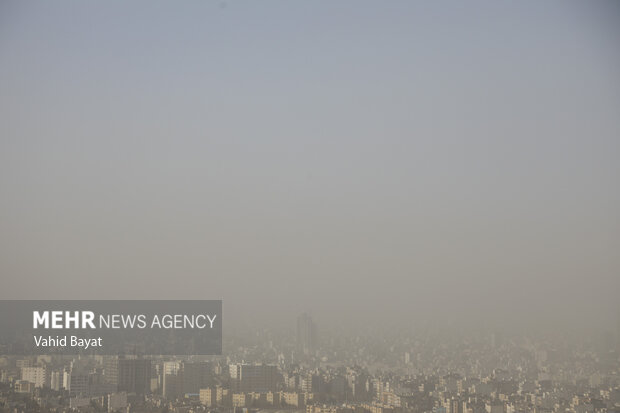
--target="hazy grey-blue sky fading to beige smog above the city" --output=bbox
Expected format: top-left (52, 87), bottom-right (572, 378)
top-left (0, 1), bottom-right (620, 328)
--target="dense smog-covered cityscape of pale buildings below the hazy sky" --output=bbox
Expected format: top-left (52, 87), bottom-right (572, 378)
top-left (0, 314), bottom-right (620, 413)
